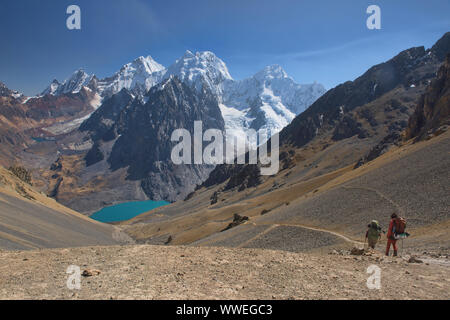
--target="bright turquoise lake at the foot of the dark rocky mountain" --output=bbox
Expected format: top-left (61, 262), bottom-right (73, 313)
top-left (91, 200), bottom-right (170, 222)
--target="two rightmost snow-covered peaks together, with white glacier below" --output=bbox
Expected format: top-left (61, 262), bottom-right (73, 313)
top-left (163, 51), bottom-right (326, 137)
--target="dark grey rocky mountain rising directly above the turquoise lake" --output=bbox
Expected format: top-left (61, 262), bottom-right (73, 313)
top-left (108, 78), bottom-right (224, 200)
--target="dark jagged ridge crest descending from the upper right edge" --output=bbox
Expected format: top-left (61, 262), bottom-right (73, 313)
top-left (280, 33), bottom-right (450, 147)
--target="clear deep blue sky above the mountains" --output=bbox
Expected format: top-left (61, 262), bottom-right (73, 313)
top-left (0, 0), bottom-right (450, 95)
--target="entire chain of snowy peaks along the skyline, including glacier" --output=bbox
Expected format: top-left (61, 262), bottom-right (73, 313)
top-left (41, 51), bottom-right (326, 136)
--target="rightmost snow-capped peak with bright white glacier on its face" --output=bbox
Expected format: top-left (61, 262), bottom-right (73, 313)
top-left (221, 65), bottom-right (325, 139)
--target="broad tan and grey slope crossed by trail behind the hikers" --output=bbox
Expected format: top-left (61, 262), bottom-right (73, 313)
top-left (123, 132), bottom-right (450, 251)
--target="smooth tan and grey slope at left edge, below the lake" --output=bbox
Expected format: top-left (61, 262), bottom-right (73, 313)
top-left (0, 167), bottom-right (132, 250)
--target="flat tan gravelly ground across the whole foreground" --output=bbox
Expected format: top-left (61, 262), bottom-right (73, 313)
top-left (0, 246), bottom-right (450, 300)
